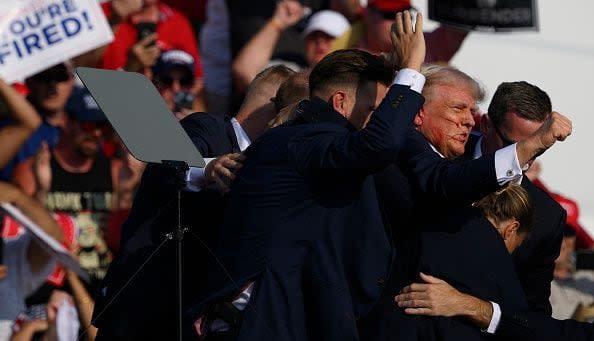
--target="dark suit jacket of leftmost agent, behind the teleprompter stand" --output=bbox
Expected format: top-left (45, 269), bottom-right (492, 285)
top-left (93, 113), bottom-right (239, 340)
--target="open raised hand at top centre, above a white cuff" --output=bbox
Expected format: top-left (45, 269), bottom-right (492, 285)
top-left (389, 11), bottom-right (425, 71)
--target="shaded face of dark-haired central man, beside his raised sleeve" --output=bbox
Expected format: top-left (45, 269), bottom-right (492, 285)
top-left (347, 82), bottom-right (388, 129)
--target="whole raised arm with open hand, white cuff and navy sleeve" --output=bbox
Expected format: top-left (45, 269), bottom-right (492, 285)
top-left (289, 12), bottom-right (425, 173)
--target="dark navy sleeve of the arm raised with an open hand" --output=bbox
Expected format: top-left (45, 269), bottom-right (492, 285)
top-left (288, 85), bottom-right (424, 173)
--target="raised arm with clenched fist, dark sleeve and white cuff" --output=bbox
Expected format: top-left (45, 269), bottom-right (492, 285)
top-left (398, 112), bottom-right (572, 202)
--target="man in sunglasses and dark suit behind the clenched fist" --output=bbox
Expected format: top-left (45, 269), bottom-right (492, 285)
top-left (465, 82), bottom-right (565, 315)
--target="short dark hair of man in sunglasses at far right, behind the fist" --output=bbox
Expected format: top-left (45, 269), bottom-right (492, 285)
top-left (488, 81), bottom-right (553, 127)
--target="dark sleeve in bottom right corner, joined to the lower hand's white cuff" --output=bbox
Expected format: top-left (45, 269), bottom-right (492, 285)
top-left (496, 311), bottom-right (594, 341)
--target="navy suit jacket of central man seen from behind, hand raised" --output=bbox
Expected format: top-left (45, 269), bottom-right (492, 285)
top-left (191, 85), bottom-right (423, 340)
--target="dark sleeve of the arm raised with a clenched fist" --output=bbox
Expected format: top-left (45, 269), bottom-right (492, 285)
top-left (398, 130), bottom-right (499, 202)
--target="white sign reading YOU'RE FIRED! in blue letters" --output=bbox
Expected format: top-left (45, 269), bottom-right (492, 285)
top-left (0, 0), bottom-right (113, 82)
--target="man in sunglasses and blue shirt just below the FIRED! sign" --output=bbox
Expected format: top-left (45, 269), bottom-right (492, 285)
top-left (0, 63), bottom-right (74, 187)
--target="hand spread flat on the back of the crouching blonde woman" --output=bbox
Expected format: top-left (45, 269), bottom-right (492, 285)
top-left (394, 273), bottom-right (493, 329)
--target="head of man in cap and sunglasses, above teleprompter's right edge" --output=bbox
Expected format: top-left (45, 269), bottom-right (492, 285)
top-left (153, 50), bottom-right (198, 120)
